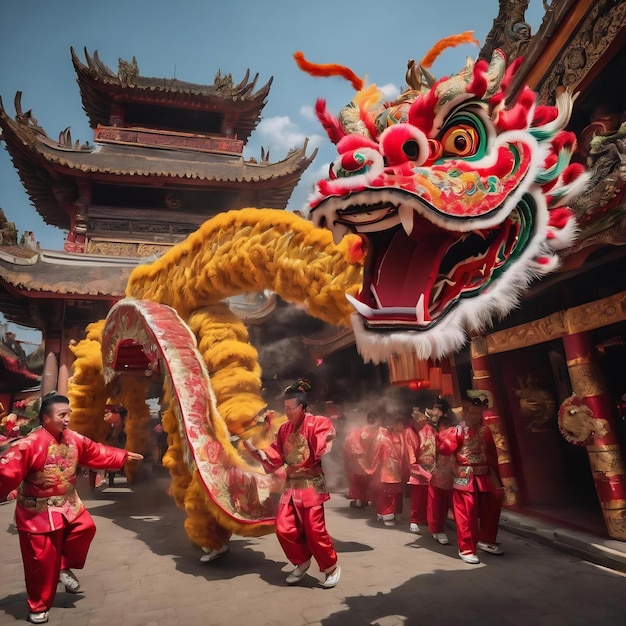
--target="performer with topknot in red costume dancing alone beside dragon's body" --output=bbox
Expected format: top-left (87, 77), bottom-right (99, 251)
top-left (244, 379), bottom-right (341, 587)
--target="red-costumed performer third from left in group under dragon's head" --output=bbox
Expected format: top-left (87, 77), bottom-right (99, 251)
top-left (404, 407), bottom-right (436, 534)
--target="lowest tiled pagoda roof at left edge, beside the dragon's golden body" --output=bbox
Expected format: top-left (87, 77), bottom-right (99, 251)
top-left (0, 246), bottom-right (136, 328)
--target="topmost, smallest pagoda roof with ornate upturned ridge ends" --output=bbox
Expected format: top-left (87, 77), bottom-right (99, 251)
top-left (71, 48), bottom-right (273, 141)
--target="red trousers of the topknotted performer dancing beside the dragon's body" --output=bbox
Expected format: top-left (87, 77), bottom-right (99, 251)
top-left (276, 499), bottom-right (337, 573)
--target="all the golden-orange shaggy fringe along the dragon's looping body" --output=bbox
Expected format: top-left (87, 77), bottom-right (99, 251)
top-left (72, 207), bottom-right (360, 548)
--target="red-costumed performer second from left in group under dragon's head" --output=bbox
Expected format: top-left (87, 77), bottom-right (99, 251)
top-left (369, 414), bottom-right (404, 526)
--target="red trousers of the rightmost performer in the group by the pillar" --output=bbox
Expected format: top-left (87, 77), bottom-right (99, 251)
top-left (452, 489), bottom-right (504, 554)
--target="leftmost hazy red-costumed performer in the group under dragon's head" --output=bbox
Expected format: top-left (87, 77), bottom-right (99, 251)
top-left (343, 413), bottom-right (380, 509)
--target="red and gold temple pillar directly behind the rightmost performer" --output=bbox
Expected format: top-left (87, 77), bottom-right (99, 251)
top-left (470, 336), bottom-right (519, 506)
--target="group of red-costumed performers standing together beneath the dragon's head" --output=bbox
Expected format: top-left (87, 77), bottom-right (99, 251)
top-left (343, 390), bottom-right (504, 564)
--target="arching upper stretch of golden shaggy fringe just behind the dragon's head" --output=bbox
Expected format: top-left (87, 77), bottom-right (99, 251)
top-left (126, 209), bottom-right (362, 326)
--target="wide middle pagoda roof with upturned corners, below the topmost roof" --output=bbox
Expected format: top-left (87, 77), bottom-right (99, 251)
top-left (0, 92), bottom-right (317, 229)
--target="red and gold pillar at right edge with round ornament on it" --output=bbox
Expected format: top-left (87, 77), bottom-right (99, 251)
top-left (563, 332), bottom-right (626, 540)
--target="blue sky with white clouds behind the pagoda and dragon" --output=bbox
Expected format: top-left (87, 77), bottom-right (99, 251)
top-left (0, 0), bottom-right (543, 338)
